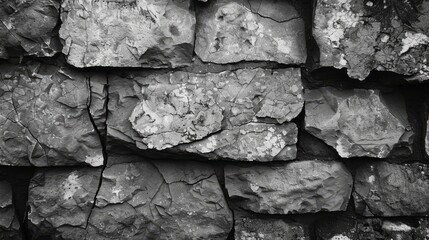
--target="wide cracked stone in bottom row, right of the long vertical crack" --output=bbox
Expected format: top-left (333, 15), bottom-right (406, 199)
top-left (88, 156), bottom-right (232, 240)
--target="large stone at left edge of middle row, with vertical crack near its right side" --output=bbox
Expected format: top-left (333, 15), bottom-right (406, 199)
top-left (0, 62), bottom-right (107, 166)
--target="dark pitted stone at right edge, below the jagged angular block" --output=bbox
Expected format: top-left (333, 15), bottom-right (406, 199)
top-left (353, 162), bottom-right (429, 216)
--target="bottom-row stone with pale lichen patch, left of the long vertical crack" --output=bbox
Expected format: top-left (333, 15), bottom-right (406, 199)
top-left (28, 168), bottom-right (101, 239)
